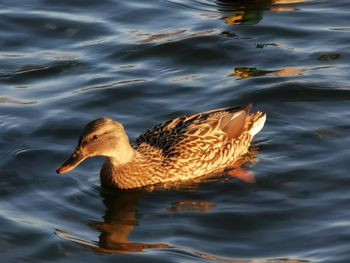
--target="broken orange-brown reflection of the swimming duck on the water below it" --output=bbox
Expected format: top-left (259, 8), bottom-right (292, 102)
top-left (56, 147), bottom-right (259, 255)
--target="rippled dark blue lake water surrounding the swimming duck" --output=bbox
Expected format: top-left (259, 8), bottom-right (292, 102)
top-left (0, 0), bottom-right (350, 263)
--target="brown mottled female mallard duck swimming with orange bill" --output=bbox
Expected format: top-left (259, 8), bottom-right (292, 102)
top-left (57, 104), bottom-right (266, 189)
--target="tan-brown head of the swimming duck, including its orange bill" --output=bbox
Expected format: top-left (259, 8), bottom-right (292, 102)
top-left (57, 118), bottom-right (133, 173)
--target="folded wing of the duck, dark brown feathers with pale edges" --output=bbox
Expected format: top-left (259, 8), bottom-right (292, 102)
top-left (136, 104), bottom-right (252, 158)
